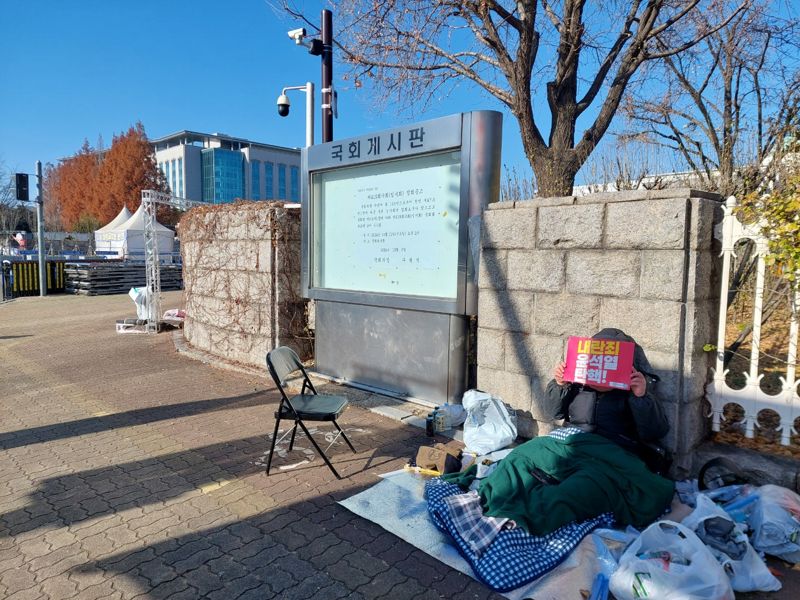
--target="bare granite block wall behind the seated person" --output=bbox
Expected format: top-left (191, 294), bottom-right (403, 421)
top-left (478, 189), bottom-right (721, 467)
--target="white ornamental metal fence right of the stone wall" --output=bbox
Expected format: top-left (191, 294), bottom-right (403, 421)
top-left (706, 197), bottom-right (800, 445)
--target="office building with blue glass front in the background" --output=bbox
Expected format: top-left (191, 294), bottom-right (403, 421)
top-left (151, 131), bottom-right (300, 204)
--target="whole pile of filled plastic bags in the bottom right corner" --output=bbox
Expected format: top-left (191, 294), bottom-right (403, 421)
top-left (608, 485), bottom-right (800, 600)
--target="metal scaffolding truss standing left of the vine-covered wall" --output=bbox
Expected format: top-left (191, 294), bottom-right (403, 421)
top-left (142, 190), bottom-right (207, 333)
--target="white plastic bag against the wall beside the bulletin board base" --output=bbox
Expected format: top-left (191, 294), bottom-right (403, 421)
top-left (461, 390), bottom-right (517, 455)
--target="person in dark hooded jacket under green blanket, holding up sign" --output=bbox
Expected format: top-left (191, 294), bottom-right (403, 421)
top-left (442, 329), bottom-right (674, 535)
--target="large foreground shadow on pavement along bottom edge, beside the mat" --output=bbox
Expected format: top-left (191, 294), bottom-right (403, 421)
top-left (70, 485), bottom-right (488, 600)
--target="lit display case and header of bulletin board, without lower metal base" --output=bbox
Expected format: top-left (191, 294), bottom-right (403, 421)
top-left (303, 111), bottom-right (500, 314)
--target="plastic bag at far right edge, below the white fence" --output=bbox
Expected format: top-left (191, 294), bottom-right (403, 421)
top-left (747, 485), bottom-right (800, 563)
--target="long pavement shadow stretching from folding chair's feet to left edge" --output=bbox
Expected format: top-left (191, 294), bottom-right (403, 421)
top-left (0, 426), bottom-right (416, 539)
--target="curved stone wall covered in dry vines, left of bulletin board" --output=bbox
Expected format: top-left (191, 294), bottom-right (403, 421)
top-left (180, 202), bottom-right (311, 367)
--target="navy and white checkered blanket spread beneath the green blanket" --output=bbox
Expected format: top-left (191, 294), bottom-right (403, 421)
top-left (425, 478), bottom-right (614, 592)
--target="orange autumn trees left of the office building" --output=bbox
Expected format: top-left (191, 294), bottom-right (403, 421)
top-left (45, 123), bottom-right (172, 230)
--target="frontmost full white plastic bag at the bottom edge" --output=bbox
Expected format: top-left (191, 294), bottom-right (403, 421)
top-left (609, 521), bottom-right (734, 600)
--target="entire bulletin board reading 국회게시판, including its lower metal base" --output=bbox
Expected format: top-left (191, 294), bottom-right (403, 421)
top-left (301, 111), bottom-right (502, 404)
